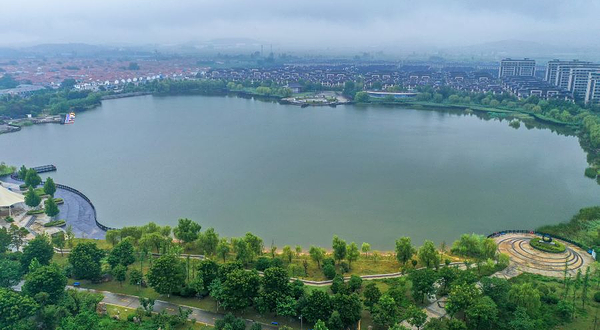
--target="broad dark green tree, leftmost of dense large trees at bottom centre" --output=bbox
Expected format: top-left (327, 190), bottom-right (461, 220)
top-left (222, 269), bottom-right (260, 310)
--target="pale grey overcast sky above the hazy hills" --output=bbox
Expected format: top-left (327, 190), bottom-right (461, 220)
top-left (0, 0), bottom-right (600, 48)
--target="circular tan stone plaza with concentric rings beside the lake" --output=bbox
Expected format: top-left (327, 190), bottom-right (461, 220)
top-left (494, 233), bottom-right (594, 277)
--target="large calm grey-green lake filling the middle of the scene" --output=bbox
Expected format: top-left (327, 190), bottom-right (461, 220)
top-left (0, 96), bottom-right (600, 249)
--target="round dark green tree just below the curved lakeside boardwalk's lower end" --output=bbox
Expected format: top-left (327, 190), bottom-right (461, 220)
top-left (69, 242), bottom-right (104, 281)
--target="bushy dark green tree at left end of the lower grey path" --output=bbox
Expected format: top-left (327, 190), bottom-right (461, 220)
top-left (23, 264), bottom-right (67, 303)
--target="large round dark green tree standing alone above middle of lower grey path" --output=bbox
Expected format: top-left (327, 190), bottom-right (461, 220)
top-left (146, 254), bottom-right (185, 296)
